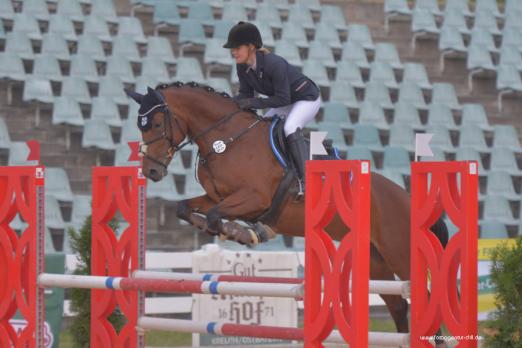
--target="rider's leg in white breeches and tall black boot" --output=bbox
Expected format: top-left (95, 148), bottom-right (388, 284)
top-left (285, 97), bottom-right (321, 189)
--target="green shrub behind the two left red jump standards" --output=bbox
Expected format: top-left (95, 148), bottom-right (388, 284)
top-left (67, 216), bottom-right (125, 348)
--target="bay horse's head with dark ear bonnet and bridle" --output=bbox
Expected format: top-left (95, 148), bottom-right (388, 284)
top-left (125, 87), bottom-right (186, 181)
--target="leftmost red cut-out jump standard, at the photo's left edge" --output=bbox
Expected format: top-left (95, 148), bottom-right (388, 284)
top-left (0, 166), bottom-right (45, 348)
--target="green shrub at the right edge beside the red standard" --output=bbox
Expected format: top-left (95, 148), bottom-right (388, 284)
top-left (486, 236), bottom-right (522, 348)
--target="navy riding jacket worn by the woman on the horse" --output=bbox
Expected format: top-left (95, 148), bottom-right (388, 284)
top-left (234, 51), bottom-right (319, 109)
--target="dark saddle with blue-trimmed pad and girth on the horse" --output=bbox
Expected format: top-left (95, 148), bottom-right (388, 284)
top-left (256, 116), bottom-right (341, 225)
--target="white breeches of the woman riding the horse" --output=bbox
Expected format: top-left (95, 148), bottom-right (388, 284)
top-left (263, 96), bottom-right (322, 136)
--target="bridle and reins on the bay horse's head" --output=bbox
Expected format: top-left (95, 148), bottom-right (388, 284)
top-left (139, 95), bottom-right (241, 170)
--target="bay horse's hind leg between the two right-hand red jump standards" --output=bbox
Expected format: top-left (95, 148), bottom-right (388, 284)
top-left (370, 245), bottom-right (409, 333)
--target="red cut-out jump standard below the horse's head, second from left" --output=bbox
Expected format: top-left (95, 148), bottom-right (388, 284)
top-left (91, 167), bottom-right (146, 348)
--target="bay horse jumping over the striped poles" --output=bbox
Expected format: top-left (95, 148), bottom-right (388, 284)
top-left (126, 82), bottom-right (448, 342)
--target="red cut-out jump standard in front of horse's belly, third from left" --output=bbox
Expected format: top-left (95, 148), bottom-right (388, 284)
top-left (304, 161), bottom-right (370, 348)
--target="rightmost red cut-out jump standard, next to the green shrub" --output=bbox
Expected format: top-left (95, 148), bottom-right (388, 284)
top-left (411, 161), bottom-right (478, 347)
